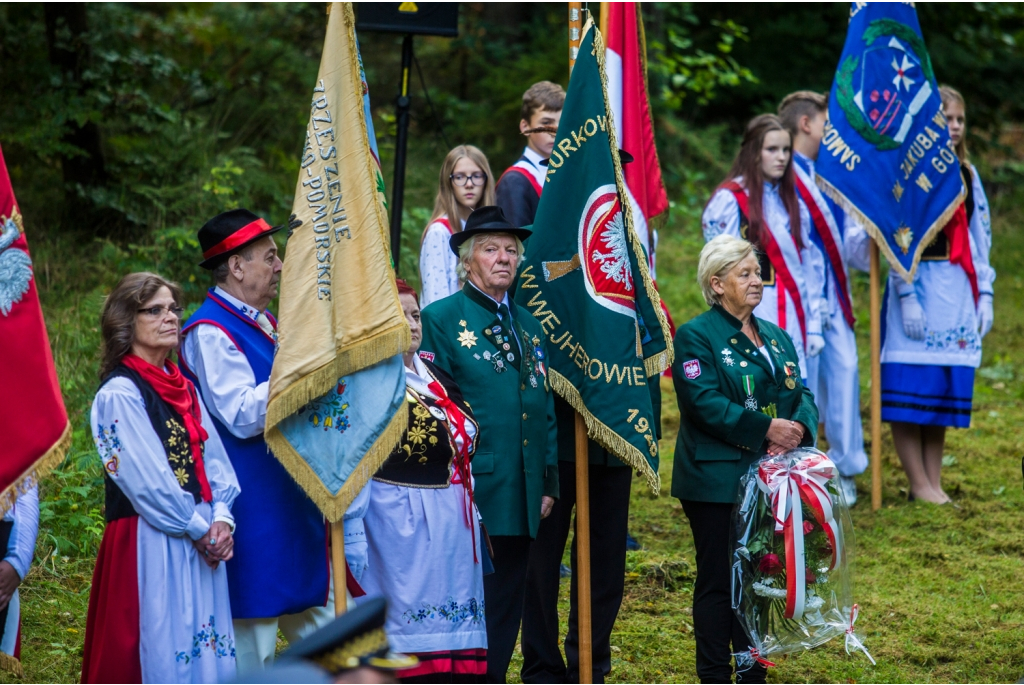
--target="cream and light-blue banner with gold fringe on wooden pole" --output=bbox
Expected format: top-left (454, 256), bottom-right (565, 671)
top-left (266, 2), bottom-right (410, 613)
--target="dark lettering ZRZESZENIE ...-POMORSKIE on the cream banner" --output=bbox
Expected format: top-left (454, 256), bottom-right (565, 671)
top-left (302, 79), bottom-right (352, 300)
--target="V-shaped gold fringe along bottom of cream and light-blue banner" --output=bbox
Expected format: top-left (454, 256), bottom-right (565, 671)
top-left (265, 401), bottom-right (409, 523)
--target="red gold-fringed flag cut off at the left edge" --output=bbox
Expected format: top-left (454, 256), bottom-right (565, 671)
top-left (0, 144), bottom-right (72, 515)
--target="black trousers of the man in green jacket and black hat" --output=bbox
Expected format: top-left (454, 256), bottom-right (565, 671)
top-left (483, 536), bottom-right (530, 683)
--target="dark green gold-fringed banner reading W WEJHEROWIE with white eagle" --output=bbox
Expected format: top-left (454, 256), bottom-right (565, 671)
top-left (515, 23), bottom-right (672, 493)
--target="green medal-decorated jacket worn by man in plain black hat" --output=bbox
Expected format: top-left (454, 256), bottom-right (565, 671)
top-left (420, 284), bottom-right (558, 538)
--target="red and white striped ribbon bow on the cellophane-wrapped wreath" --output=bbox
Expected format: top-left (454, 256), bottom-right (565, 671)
top-left (757, 454), bottom-right (843, 619)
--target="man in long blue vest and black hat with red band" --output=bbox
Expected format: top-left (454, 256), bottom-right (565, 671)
top-left (181, 209), bottom-right (334, 674)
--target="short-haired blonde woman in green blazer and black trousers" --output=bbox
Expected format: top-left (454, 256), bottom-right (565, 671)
top-left (672, 236), bottom-right (818, 683)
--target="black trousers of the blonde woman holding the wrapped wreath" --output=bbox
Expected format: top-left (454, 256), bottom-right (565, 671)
top-left (680, 500), bottom-right (767, 683)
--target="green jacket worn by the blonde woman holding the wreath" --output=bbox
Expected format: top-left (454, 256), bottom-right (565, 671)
top-left (672, 305), bottom-right (818, 503)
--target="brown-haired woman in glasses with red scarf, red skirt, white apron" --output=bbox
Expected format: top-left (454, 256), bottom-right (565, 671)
top-left (82, 273), bottom-right (239, 683)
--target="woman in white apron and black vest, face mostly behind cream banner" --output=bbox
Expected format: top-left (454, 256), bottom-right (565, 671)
top-left (361, 279), bottom-right (487, 683)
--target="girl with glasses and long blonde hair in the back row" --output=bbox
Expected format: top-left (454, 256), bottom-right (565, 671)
top-left (420, 145), bottom-right (495, 308)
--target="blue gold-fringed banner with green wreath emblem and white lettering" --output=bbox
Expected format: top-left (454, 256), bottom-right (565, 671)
top-left (815, 2), bottom-right (965, 281)
